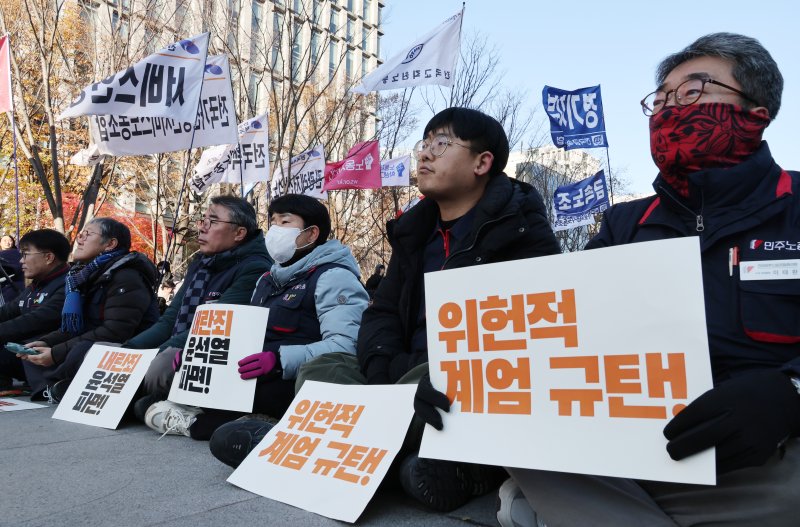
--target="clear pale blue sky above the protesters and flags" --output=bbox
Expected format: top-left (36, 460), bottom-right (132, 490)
top-left (381, 0), bottom-right (800, 194)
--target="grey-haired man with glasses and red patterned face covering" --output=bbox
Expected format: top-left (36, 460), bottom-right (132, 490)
top-left (498, 33), bottom-right (800, 527)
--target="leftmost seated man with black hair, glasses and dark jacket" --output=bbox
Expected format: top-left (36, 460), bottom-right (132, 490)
top-left (0, 229), bottom-right (70, 394)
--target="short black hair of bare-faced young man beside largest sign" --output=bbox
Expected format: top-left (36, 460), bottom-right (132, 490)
top-left (423, 106), bottom-right (509, 176)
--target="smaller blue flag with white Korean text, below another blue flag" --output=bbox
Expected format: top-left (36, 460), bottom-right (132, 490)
top-left (553, 170), bottom-right (609, 231)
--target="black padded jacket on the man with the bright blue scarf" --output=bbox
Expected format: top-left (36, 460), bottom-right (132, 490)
top-left (41, 252), bottom-right (158, 364)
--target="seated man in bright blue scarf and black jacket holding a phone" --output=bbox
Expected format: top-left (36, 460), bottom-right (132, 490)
top-left (19, 218), bottom-right (158, 402)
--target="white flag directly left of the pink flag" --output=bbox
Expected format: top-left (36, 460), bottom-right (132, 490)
top-left (269, 145), bottom-right (328, 199)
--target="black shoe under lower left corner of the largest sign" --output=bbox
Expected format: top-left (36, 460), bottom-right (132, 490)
top-left (400, 454), bottom-right (472, 512)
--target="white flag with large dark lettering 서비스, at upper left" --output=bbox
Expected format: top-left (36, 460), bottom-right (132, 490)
top-left (58, 33), bottom-right (209, 122)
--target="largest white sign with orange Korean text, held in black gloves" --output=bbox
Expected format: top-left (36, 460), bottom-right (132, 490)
top-left (420, 237), bottom-right (716, 484)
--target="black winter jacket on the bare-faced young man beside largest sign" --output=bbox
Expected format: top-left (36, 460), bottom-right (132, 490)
top-left (357, 174), bottom-right (560, 384)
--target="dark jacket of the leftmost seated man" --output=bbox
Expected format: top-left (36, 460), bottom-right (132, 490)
top-left (0, 264), bottom-right (69, 345)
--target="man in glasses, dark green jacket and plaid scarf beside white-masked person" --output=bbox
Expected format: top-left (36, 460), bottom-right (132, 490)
top-left (125, 196), bottom-right (272, 421)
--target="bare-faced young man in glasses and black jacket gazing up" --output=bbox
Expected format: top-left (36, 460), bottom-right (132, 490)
top-left (290, 108), bottom-right (559, 511)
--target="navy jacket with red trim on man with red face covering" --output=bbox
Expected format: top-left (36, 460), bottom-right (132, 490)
top-left (586, 142), bottom-right (800, 383)
